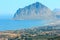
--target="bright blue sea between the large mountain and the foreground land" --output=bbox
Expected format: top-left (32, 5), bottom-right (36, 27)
top-left (0, 20), bottom-right (50, 31)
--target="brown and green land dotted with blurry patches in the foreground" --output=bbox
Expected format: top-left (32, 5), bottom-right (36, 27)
top-left (0, 26), bottom-right (60, 40)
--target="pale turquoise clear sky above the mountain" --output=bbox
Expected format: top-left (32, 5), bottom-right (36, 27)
top-left (0, 0), bottom-right (60, 19)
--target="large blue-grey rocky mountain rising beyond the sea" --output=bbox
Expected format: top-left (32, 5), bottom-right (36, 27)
top-left (13, 2), bottom-right (53, 20)
